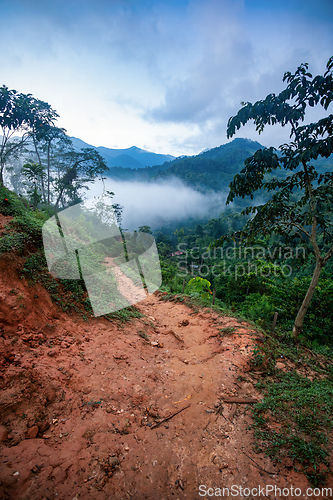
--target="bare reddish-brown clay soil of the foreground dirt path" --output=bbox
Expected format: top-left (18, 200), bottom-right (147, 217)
top-left (0, 217), bottom-right (325, 500)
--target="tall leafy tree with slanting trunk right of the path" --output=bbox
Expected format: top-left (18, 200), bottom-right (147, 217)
top-left (227, 57), bottom-right (333, 338)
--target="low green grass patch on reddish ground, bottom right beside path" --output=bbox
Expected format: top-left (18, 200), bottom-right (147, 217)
top-left (252, 360), bottom-right (333, 486)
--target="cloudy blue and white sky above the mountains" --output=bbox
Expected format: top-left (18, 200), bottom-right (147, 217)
top-left (0, 0), bottom-right (333, 156)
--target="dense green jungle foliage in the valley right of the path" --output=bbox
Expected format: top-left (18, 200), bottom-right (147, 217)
top-left (156, 212), bottom-right (333, 346)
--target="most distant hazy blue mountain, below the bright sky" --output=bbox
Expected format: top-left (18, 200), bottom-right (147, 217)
top-left (70, 137), bottom-right (175, 168)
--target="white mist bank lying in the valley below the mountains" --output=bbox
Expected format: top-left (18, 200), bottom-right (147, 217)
top-left (86, 178), bottom-right (226, 230)
